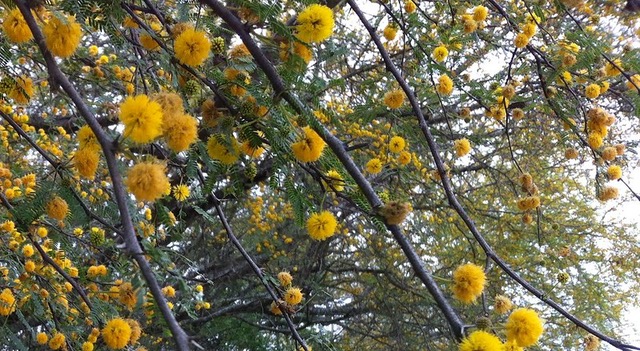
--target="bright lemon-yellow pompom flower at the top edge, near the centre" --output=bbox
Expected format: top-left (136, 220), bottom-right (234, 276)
top-left (295, 4), bottom-right (334, 43)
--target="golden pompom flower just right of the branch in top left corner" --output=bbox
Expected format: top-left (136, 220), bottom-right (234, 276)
top-left (42, 15), bottom-right (82, 58)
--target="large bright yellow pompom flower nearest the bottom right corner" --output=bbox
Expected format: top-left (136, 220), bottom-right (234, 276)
top-left (505, 308), bottom-right (543, 347)
